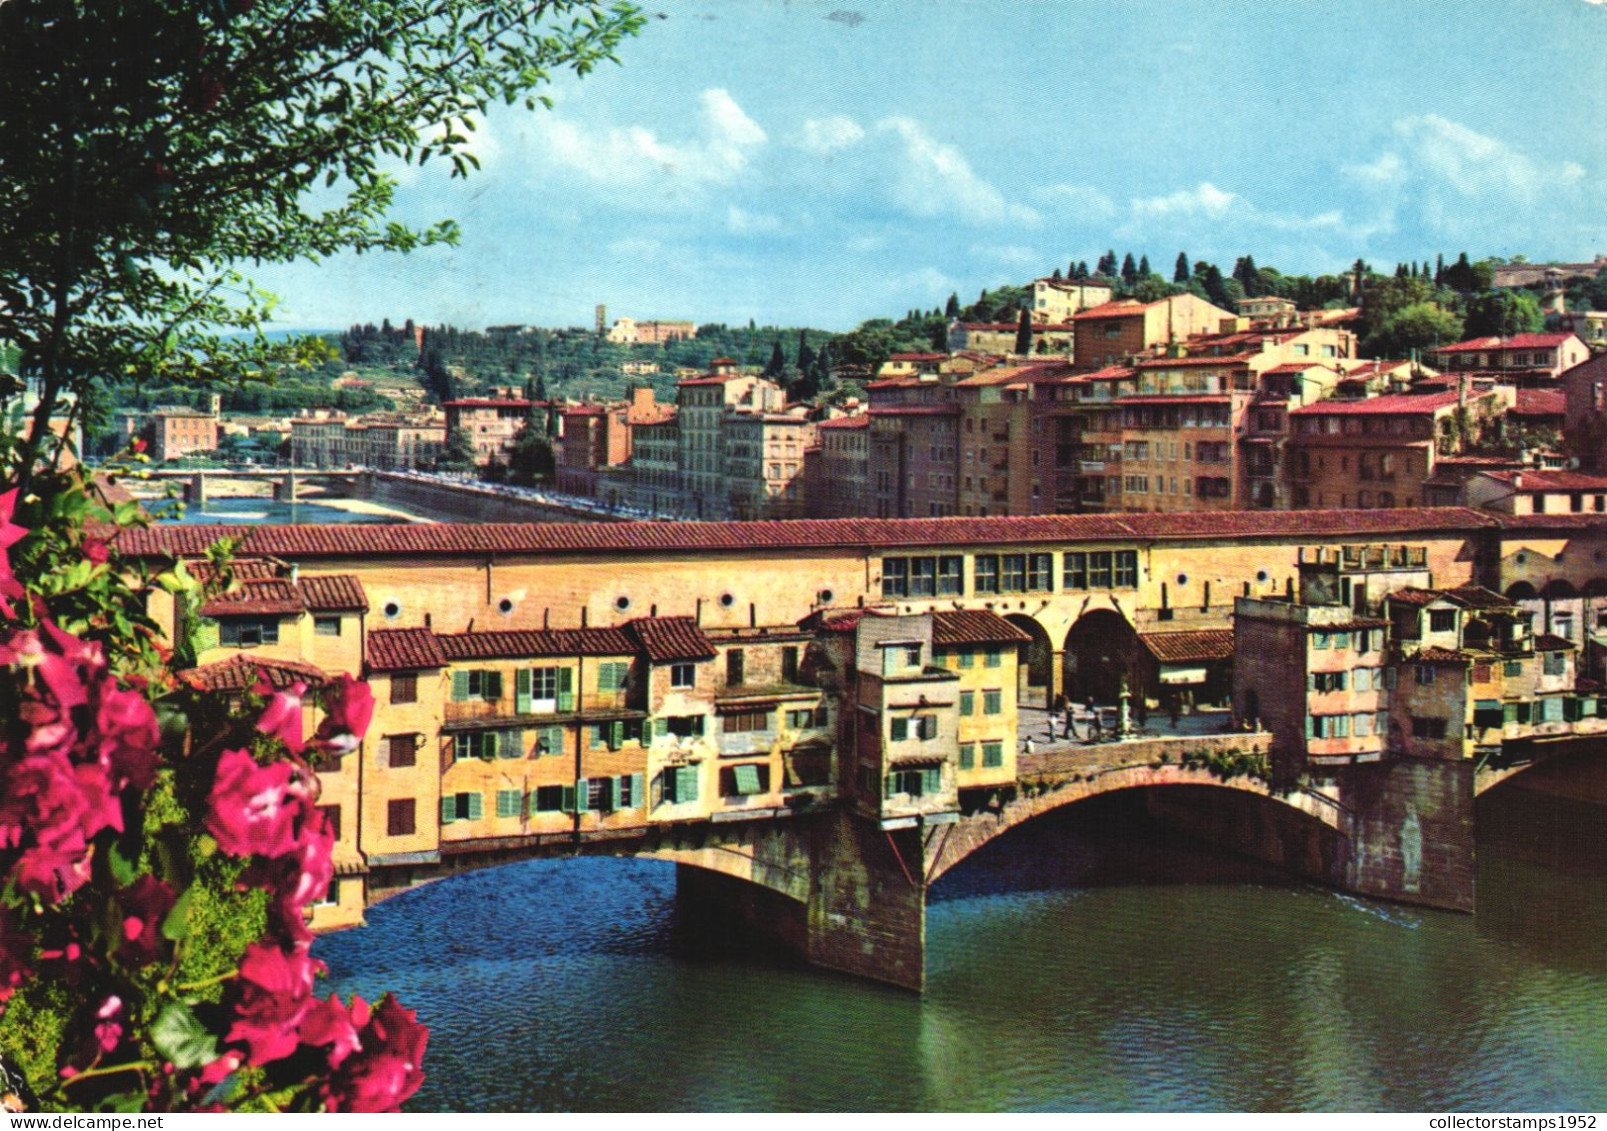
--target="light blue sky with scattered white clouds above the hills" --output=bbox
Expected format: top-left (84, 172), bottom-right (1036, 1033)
top-left (254, 0), bottom-right (1607, 329)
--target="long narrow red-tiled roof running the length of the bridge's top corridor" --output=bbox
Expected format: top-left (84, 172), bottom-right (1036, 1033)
top-left (117, 506), bottom-right (1504, 561)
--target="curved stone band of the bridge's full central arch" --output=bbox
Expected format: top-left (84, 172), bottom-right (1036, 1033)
top-left (926, 765), bottom-right (1347, 884)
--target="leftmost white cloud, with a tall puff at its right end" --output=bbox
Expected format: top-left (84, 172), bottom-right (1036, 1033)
top-left (543, 88), bottom-right (767, 185)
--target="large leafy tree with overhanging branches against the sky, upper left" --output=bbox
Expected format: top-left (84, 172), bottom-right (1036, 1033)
top-left (0, 0), bottom-right (643, 479)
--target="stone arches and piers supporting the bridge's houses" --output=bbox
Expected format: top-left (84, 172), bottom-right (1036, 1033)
top-left (345, 733), bottom-right (1600, 991)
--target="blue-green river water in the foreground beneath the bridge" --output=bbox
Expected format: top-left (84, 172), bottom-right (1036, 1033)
top-left (317, 767), bottom-right (1607, 1112)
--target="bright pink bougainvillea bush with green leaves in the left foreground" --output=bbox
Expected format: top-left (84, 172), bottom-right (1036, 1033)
top-left (0, 462), bottom-right (427, 1112)
